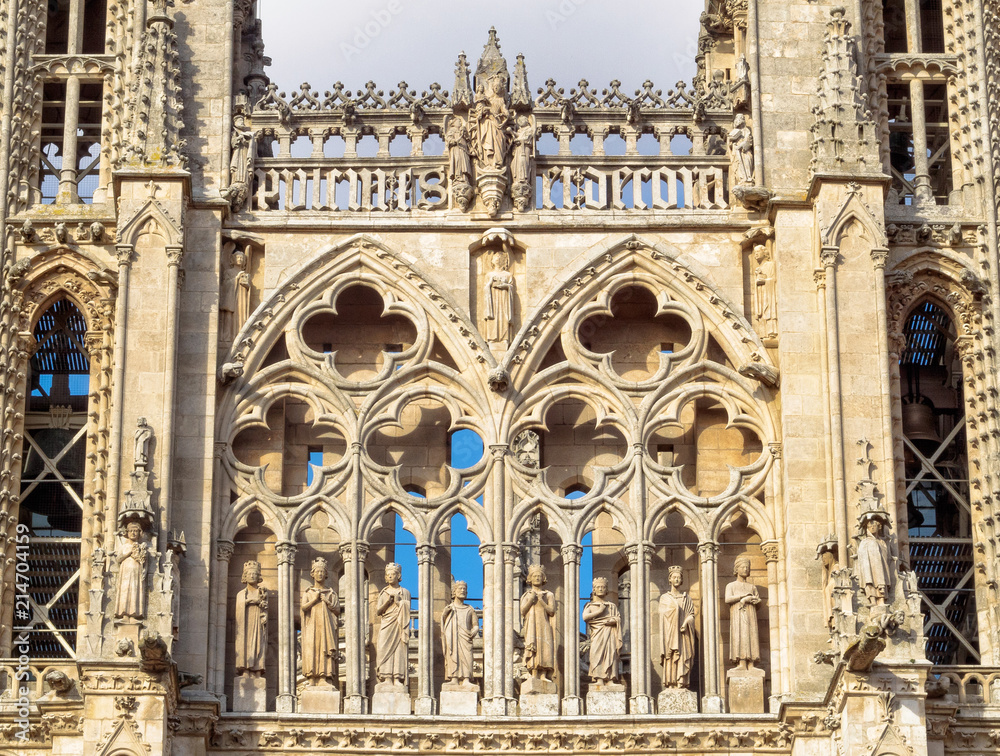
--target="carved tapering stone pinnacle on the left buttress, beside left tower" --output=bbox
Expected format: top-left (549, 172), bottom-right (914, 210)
top-left (115, 0), bottom-right (187, 169)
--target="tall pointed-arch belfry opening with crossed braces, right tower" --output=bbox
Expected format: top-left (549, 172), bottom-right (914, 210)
top-left (899, 302), bottom-right (980, 664)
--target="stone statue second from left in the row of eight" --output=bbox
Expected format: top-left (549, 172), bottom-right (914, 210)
top-left (300, 557), bottom-right (340, 685)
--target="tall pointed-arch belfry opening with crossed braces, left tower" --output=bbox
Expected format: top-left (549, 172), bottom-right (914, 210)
top-left (15, 299), bottom-right (90, 659)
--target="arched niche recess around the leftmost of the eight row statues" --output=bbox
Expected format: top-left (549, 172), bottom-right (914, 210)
top-left (225, 509), bottom-right (280, 711)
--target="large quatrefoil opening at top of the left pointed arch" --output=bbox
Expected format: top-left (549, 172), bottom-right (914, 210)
top-left (301, 284), bottom-right (417, 383)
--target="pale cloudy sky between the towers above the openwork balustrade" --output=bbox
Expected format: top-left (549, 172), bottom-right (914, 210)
top-left (260, 0), bottom-right (702, 94)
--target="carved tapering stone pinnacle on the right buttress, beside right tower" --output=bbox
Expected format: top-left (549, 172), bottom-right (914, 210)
top-left (811, 7), bottom-right (882, 173)
